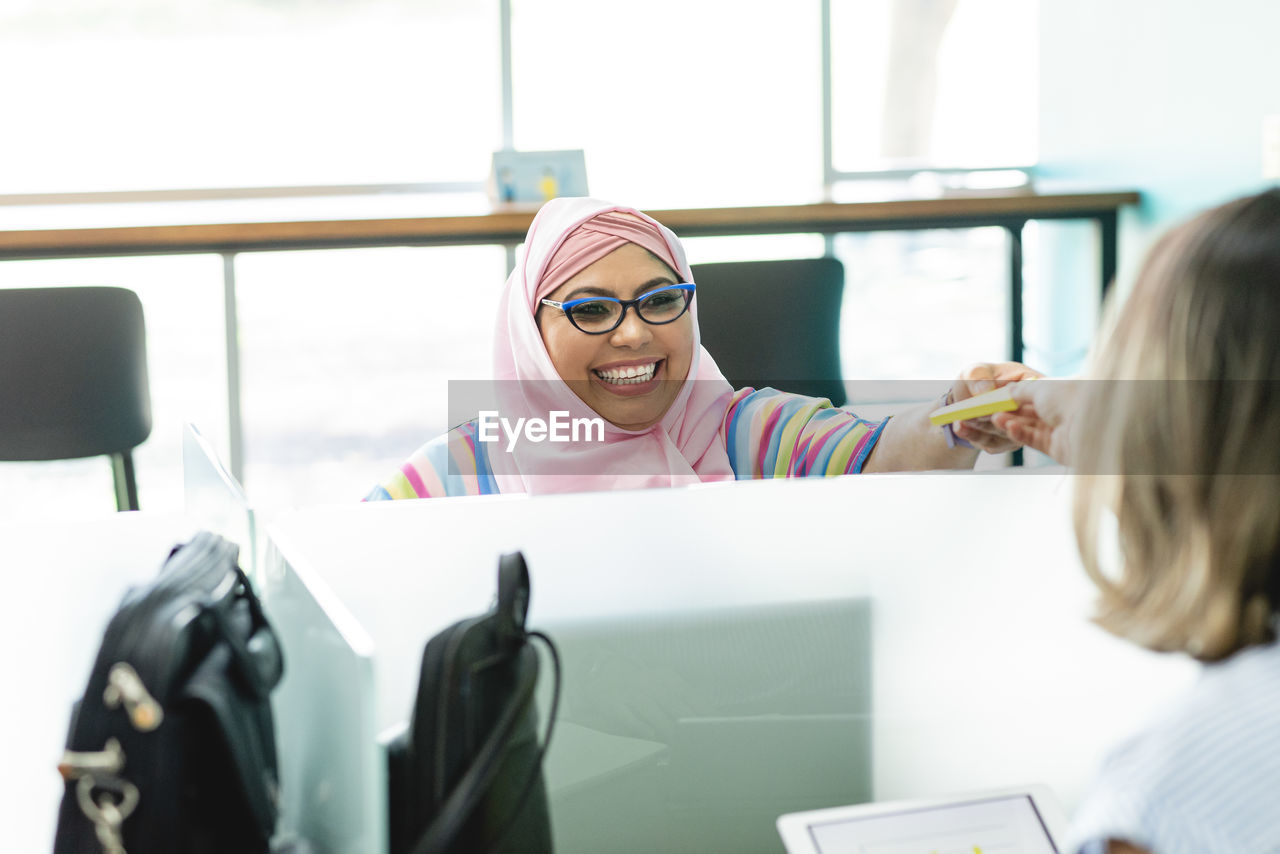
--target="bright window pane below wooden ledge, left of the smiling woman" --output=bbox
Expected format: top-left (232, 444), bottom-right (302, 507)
top-left (236, 246), bottom-right (506, 507)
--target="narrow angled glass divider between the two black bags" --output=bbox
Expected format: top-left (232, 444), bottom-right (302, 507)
top-left (183, 424), bottom-right (387, 854)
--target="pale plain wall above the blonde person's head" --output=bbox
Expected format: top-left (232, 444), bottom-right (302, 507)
top-left (1039, 0), bottom-right (1280, 263)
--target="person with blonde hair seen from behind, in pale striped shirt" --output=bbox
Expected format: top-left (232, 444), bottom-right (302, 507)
top-left (992, 188), bottom-right (1280, 854)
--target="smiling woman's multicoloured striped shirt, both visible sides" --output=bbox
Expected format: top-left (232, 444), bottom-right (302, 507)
top-left (365, 388), bottom-right (887, 501)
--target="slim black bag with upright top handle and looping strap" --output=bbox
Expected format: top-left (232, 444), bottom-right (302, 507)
top-left (388, 552), bottom-right (561, 854)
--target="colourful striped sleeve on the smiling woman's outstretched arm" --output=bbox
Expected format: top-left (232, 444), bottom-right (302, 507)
top-left (723, 388), bottom-right (887, 480)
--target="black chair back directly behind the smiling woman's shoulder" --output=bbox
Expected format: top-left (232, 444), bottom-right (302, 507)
top-left (694, 257), bottom-right (845, 406)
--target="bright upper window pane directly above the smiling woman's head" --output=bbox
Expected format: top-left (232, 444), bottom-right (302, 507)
top-left (512, 0), bottom-right (822, 207)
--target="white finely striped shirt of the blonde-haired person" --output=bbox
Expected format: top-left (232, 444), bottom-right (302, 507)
top-left (1065, 644), bottom-right (1280, 854)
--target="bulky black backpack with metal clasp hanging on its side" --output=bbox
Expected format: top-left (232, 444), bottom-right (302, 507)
top-left (54, 533), bottom-right (284, 854)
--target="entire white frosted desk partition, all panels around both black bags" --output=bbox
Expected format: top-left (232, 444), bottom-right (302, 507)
top-left (17, 460), bottom-right (1196, 854)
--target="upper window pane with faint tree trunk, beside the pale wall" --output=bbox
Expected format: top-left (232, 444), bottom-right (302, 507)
top-left (831, 0), bottom-right (1039, 172)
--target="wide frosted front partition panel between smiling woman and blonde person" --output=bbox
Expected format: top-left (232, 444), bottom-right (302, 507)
top-left (270, 474), bottom-right (1189, 854)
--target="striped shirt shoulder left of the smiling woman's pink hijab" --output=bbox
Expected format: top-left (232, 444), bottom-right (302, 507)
top-left (365, 421), bottom-right (498, 501)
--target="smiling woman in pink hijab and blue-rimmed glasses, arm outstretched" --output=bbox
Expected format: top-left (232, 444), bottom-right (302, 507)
top-left (367, 198), bottom-right (1033, 499)
